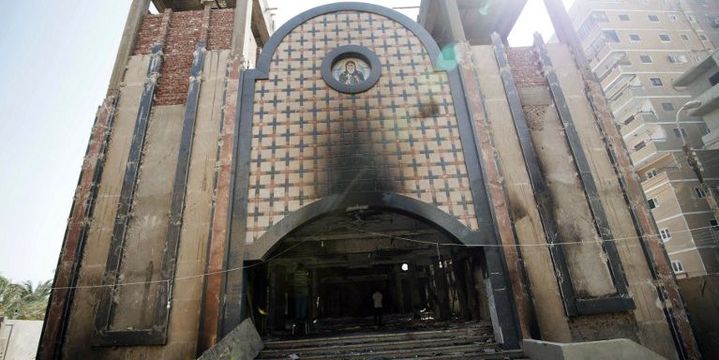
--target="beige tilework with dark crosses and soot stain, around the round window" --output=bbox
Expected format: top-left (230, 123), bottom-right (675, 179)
top-left (246, 11), bottom-right (477, 243)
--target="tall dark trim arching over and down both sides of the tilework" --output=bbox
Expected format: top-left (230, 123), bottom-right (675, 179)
top-left (219, 3), bottom-right (519, 348)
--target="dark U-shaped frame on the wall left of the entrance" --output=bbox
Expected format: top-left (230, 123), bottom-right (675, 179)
top-left (93, 33), bottom-right (206, 346)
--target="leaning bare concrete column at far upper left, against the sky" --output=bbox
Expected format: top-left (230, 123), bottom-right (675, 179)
top-left (107, 0), bottom-right (150, 96)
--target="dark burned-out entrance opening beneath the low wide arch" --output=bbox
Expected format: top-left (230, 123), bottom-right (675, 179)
top-left (246, 208), bottom-right (490, 337)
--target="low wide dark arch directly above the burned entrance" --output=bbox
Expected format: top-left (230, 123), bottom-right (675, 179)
top-left (247, 192), bottom-right (491, 260)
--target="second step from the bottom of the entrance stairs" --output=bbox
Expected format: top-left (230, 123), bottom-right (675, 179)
top-left (262, 336), bottom-right (495, 356)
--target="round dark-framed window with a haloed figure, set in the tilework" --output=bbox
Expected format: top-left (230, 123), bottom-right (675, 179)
top-left (322, 45), bottom-right (380, 94)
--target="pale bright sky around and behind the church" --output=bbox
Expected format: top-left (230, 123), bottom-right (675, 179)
top-left (0, 0), bottom-right (573, 283)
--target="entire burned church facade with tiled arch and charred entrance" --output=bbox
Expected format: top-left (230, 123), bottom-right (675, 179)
top-left (39, 0), bottom-right (697, 359)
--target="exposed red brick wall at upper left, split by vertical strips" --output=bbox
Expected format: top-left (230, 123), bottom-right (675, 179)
top-left (133, 9), bottom-right (234, 105)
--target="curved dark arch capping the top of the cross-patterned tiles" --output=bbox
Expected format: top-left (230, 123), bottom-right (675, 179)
top-left (250, 2), bottom-right (442, 79)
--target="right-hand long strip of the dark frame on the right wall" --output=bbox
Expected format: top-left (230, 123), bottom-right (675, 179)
top-left (534, 34), bottom-right (635, 314)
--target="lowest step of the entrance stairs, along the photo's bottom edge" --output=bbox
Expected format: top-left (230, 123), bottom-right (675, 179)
top-left (258, 344), bottom-right (497, 360)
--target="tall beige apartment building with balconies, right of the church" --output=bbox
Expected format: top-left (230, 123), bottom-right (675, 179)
top-left (569, 0), bottom-right (719, 277)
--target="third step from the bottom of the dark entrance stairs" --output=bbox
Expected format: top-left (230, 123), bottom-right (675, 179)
top-left (265, 325), bottom-right (493, 349)
